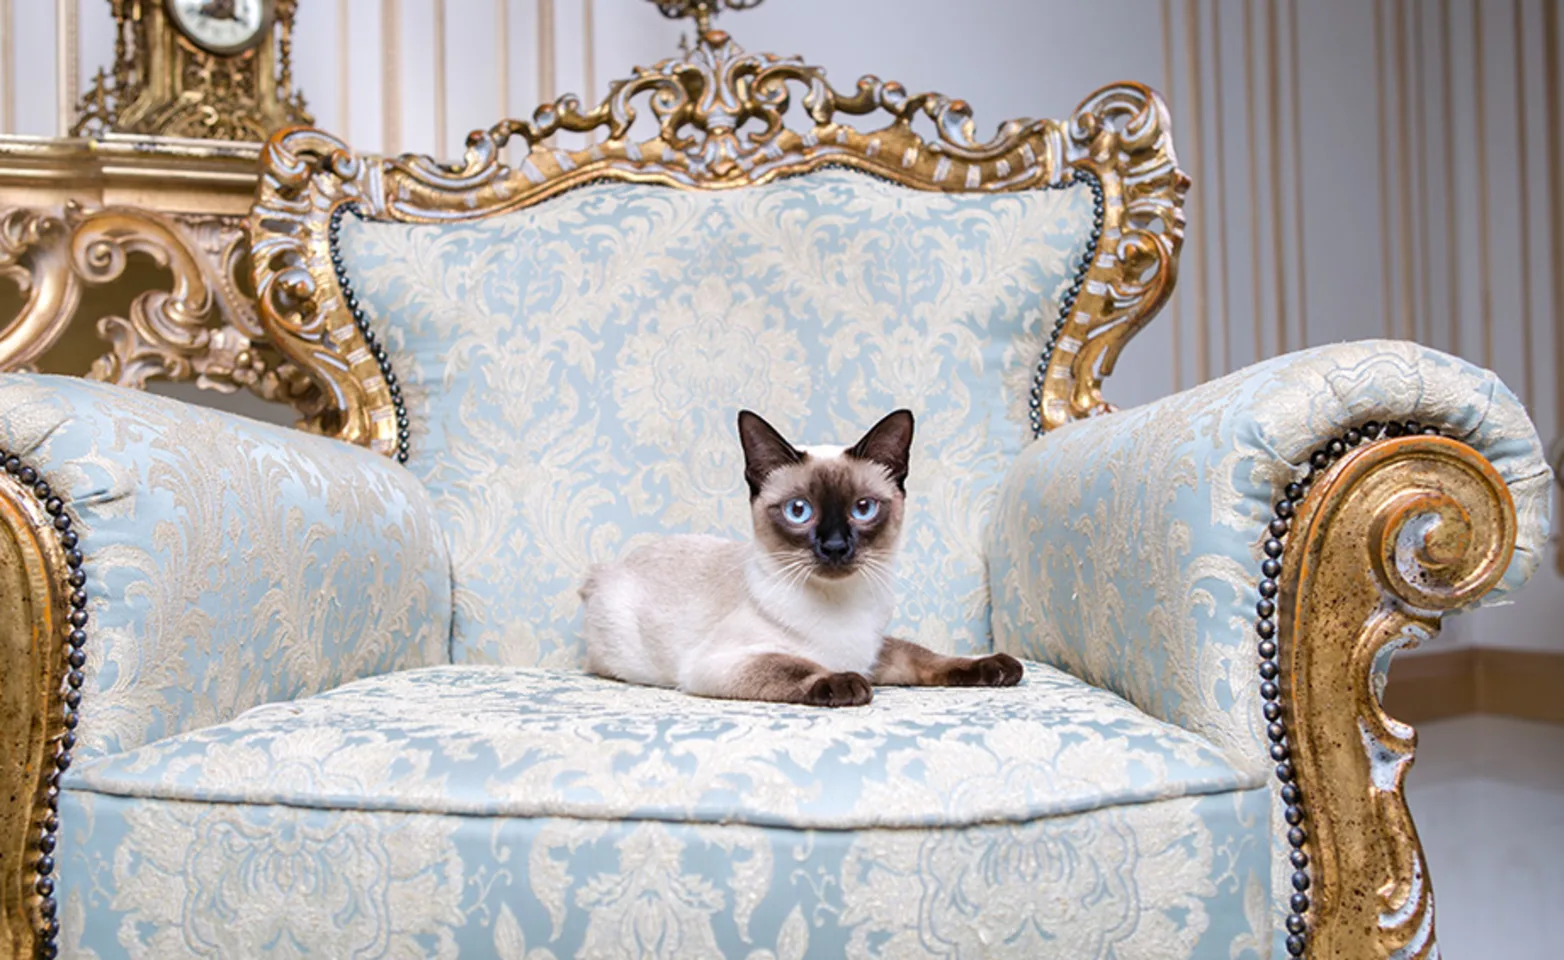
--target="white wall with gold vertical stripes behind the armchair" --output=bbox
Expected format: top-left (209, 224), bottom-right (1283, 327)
top-left (0, 0), bottom-right (1564, 649)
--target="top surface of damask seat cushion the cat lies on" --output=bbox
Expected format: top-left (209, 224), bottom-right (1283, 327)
top-left (69, 666), bottom-right (1264, 829)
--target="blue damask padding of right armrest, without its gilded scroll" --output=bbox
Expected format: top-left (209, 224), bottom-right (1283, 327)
top-left (988, 341), bottom-right (1550, 763)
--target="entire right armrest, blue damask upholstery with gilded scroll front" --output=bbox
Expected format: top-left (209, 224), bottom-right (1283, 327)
top-left (990, 341), bottom-right (1550, 957)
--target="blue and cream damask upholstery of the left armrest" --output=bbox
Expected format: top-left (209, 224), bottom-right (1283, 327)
top-left (0, 374), bottom-right (450, 760)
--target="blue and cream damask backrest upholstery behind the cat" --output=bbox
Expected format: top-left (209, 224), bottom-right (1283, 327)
top-left (341, 170), bottom-right (1092, 666)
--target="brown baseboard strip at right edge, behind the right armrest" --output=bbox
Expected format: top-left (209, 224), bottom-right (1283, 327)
top-left (1384, 647), bottom-right (1564, 724)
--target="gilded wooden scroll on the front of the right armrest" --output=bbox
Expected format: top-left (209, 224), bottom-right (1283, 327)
top-left (1279, 436), bottom-right (1516, 960)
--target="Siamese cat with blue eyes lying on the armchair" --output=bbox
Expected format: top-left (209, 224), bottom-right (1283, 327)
top-left (580, 410), bottom-right (1021, 707)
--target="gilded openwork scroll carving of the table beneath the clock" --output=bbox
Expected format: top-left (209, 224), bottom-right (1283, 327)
top-left (0, 202), bottom-right (319, 416)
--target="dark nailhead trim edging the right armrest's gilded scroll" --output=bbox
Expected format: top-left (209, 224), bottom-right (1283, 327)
top-left (1254, 421), bottom-right (1439, 957)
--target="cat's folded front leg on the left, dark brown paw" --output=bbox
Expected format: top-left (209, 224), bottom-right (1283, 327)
top-left (679, 654), bottom-right (874, 707)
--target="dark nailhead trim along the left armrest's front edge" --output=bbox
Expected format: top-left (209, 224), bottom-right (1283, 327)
top-left (0, 450), bottom-right (88, 958)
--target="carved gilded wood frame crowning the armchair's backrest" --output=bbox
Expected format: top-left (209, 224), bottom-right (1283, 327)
top-left (250, 30), bottom-right (1189, 453)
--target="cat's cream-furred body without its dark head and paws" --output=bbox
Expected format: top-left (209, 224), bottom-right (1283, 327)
top-left (582, 535), bottom-right (895, 697)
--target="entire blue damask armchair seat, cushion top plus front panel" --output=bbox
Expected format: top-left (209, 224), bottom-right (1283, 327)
top-left (61, 664), bottom-right (1268, 960)
